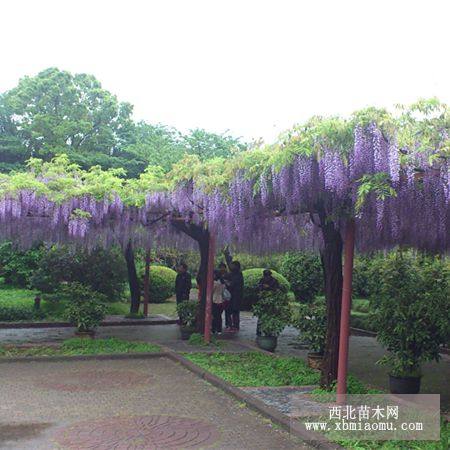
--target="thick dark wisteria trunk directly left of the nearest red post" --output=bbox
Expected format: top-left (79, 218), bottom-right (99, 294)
top-left (320, 216), bottom-right (342, 388)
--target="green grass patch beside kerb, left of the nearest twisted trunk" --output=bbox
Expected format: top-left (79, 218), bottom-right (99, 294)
top-left (184, 352), bottom-right (319, 386)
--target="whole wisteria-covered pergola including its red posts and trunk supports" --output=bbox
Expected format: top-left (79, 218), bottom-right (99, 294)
top-left (0, 103), bottom-right (450, 393)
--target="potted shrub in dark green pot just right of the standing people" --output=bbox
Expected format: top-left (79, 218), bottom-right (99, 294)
top-left (253, 291), bottom-right (291, 352)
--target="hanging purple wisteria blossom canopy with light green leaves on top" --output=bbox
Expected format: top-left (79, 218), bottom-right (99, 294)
top-left (0, 100), bottom-right (450, 253)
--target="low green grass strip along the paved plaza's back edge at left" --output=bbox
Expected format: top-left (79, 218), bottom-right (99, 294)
top-left (0, 338), bottom-right (161, 358)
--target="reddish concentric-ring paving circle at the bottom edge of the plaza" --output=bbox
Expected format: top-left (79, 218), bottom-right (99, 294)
top-left (55, 416), bottom-right (219, 450)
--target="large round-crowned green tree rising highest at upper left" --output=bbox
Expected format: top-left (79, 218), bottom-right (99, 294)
top-left (0, 68), bottom-right (134, 163)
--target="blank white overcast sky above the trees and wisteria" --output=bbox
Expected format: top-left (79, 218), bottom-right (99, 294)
top-left (0, 0), bottom-right (450, 140)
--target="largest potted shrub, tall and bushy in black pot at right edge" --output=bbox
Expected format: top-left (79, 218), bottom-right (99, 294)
top-left (371, 252), bottom-right (450, 394)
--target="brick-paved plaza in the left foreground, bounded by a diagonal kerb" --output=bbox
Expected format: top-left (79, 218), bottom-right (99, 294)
top-left (0, 358), bottom-right (307, 450)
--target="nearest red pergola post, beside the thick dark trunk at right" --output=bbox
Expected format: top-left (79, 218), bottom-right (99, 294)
top-left (337, 219), bottom-right (355, 402)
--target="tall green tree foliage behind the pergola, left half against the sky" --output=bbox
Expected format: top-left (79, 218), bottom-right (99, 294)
top-left (0, 68), bottom-right (245, 178)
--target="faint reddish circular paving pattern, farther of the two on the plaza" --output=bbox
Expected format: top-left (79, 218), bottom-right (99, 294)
top-left (34, 370), bottom-right (151, 392)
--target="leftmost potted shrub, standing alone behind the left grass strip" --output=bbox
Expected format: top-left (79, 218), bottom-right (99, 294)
top-left (62, 283), bottom-right (106, 337)
